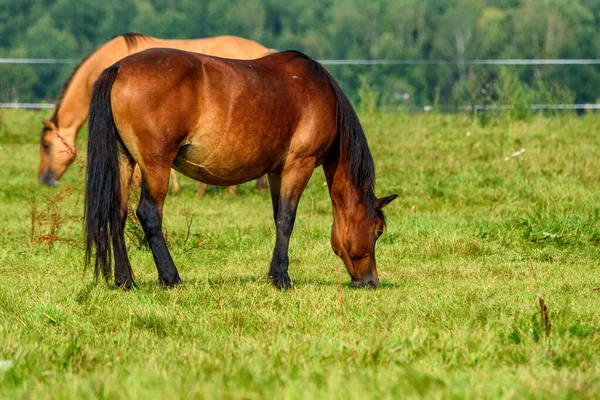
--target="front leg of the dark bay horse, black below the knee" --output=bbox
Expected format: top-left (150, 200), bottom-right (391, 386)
top-left (269, 160), bottom-right (315, 289)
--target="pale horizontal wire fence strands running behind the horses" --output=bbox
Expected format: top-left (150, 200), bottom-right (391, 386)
top-left (0, 58), bottom-right (600, 112)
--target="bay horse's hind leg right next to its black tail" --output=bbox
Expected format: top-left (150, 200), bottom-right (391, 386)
top-left (111, 151), bottom-right (135, 289)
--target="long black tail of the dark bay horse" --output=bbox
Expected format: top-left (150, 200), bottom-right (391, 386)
top-left (85, 64), bottom-right (123, 282)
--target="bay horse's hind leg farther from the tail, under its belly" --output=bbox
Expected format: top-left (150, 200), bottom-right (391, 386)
top-left (137, 165), bottom-right (181, 286)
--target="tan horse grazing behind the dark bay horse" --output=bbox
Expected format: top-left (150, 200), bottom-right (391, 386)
top-left (38, 33), bottom-right (274, 196)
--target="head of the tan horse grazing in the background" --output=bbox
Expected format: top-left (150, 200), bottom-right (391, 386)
top-left (38, 119), bottom-right (75, 187)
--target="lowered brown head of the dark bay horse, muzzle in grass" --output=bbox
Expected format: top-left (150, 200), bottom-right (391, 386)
top-left (331, 194), bottom-right (398, 288)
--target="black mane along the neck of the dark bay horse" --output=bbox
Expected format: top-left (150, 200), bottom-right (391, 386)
top-left (282, 51), bottom-right (378, 224)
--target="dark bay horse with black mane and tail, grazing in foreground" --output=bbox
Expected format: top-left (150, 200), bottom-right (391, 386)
top-left (85, 49), bottom-right (397, 288)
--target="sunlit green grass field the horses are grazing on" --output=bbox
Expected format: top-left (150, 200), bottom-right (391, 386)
top-left (0, 111), bottom-right (600, 399)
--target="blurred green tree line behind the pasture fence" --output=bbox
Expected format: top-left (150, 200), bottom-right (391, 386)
top-left (0, 0), bottom-right (600, 107)
